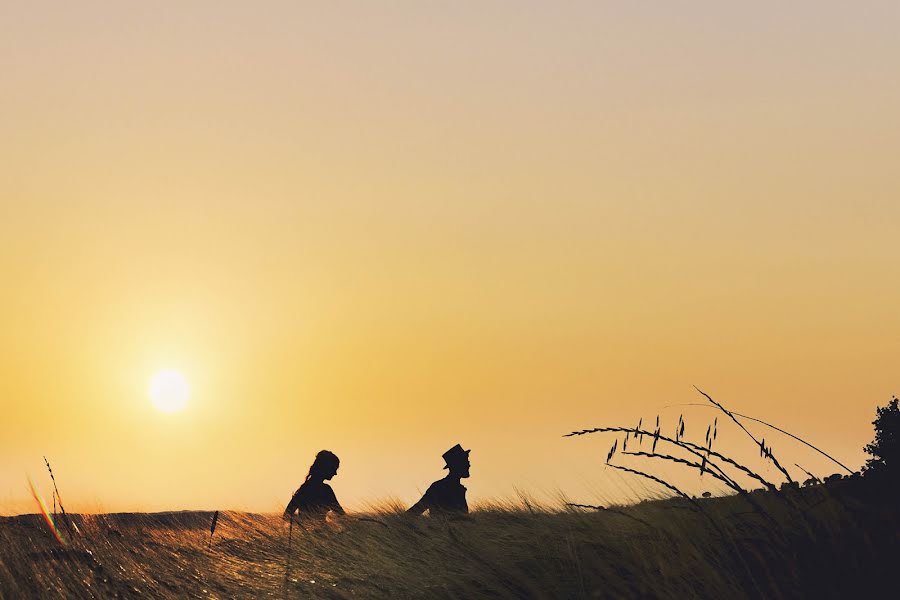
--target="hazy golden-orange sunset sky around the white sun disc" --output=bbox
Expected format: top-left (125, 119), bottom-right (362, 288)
top-left (0, 0), bottom-right (900, 514)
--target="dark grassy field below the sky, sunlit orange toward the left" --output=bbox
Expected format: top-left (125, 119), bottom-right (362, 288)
top-left (0, 478), bottom-right (900, 598)
